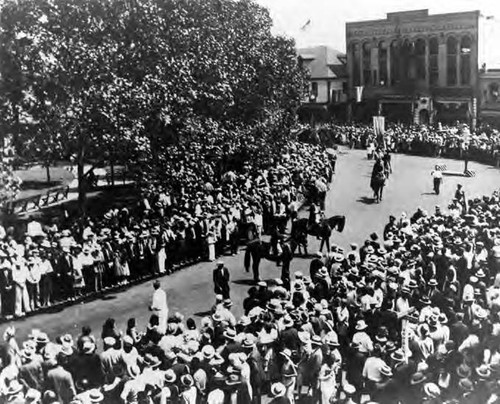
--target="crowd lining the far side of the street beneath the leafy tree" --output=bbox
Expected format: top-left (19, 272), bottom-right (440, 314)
top-left (0, 142), bottom-right (334, 318)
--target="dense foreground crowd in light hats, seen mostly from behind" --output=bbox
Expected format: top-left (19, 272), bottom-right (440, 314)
top-left (0, 184), bottom-right (500, 404)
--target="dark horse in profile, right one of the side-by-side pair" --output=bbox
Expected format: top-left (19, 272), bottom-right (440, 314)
top-left (291, 215), bottom-right (345, 255)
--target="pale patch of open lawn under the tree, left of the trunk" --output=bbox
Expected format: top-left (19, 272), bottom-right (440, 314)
top-left (15, 167), bottom-right (74, 199)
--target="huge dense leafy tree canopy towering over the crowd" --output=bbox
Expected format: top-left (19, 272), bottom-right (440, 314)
top-left (0, 0), bottom-right (304, 211)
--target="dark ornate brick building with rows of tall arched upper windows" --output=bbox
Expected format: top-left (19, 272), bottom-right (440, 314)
top-left (346, 10), bottom-right (480, 124)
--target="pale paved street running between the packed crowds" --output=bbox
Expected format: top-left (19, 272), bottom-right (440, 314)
top-left (6, 150), bottom-right (500, 337)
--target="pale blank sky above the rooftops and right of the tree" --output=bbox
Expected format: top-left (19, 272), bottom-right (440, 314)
top-left (256, 0), bottom-right (500, 68)
